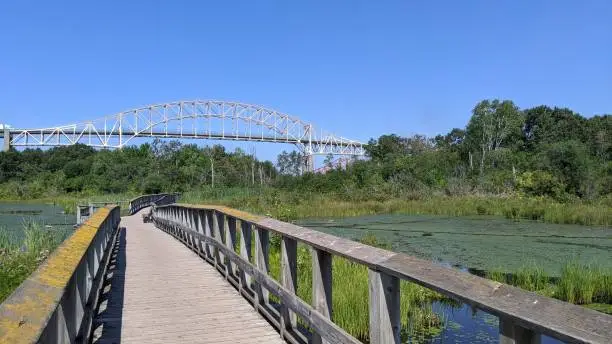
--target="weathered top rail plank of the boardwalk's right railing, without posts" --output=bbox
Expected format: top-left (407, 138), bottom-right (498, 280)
top-left (152, 205), bottom-right (612, 343)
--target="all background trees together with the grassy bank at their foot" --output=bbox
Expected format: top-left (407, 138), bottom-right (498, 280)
top-left (0, 100), bottom-right (612, 220)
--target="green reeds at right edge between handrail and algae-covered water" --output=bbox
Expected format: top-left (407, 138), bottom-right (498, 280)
top-left (487, 262), bottom-right (612, 314)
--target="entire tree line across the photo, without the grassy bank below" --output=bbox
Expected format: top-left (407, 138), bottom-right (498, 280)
top-left (0, 100), bottom-right (612, 201)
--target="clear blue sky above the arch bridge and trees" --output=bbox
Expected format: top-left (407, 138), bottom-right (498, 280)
top-left (0, 0), bottom-right (612, 159)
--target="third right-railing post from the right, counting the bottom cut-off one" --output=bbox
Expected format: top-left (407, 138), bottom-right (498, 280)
top-left (311, 247), bottom-right (332, 344)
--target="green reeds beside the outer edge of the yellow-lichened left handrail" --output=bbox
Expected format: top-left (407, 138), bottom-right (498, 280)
top-left (0, 222), bottom-right (70, 302)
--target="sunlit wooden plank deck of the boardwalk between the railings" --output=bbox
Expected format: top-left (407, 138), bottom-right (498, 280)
top-left (93, 214), bottom-right (284, 344)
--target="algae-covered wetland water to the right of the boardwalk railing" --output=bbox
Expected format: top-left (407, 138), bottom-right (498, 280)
top-left (298, 215), bottom-right (612, 343)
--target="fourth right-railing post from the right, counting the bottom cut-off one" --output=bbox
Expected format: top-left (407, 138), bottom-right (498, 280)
top-left (280, 236), bottom-right (297, 338)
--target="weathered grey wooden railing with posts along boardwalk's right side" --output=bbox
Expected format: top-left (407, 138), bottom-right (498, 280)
top-left (152, 204), bottom-right (612, 344)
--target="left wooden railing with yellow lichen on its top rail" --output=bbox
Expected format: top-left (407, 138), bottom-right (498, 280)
top-left (0, 206), bottom-right (120, 344)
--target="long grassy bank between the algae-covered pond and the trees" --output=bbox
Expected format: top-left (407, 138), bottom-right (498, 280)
top-left (181, 188), bottom-right (612, 226)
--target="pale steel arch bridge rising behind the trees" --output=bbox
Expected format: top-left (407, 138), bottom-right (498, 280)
top-left (4, 100), bottom-right (364, 167)
